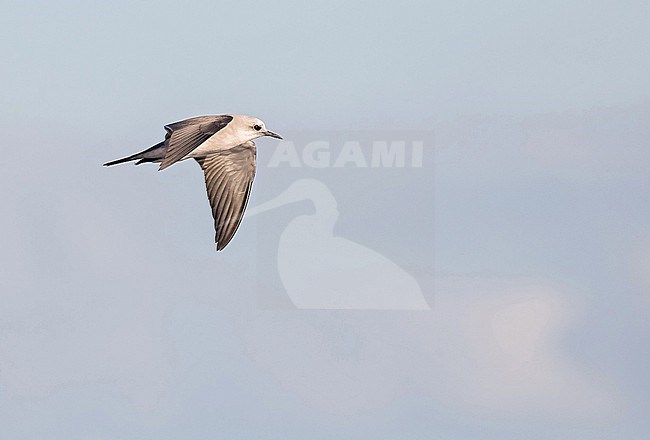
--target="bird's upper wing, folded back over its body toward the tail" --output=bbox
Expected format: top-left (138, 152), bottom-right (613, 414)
top-left (159, 115), bottom-right (232, 170)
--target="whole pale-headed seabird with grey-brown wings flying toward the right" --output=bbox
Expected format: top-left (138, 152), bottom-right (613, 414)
top-left (104, 115), bottom-right (282, 251)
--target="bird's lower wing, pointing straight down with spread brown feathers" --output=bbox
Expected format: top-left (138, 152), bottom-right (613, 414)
top-left (196, 141), bottom-right (255, 251)
